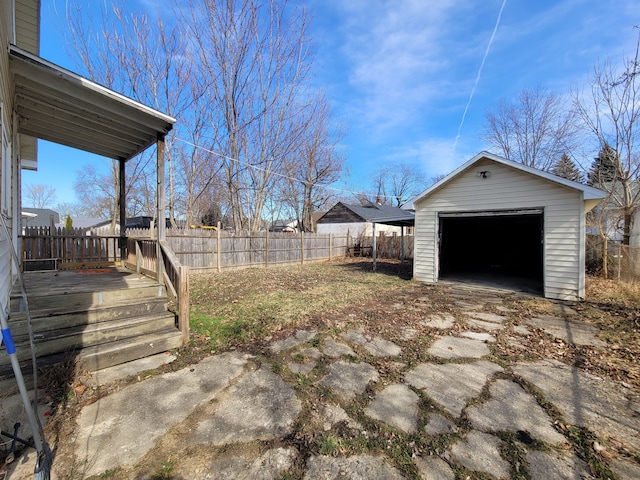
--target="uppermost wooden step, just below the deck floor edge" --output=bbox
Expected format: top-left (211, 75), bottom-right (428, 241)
top-left (9, 297), bottom-right (167, 337)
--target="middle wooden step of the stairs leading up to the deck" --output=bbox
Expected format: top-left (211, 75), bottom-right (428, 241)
top-left (0, 312), bottom-right (177, 365)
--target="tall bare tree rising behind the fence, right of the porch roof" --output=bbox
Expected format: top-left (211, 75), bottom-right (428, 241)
top-left (182, 0), bottom-right (312, 230)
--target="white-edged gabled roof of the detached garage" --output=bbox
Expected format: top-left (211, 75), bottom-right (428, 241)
top-left (402, 152), bottom-right (607, 210)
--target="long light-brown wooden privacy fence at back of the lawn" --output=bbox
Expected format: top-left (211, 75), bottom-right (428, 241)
top-left (127, 229), bottom-right (349, 272)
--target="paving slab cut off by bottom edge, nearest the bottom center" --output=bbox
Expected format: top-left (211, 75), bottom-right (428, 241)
top-left (303, 454), bottom-right (404, 480)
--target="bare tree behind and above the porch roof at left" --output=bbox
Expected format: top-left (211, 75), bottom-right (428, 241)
top-left (67, 2), bottom-right (194, 224)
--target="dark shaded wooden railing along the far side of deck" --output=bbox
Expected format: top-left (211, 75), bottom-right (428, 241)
top-left (21, 227), bottom-right (120, 271)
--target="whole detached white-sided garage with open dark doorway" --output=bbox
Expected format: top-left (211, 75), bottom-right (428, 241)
top-left (411, 152), bottom-right (605, 300)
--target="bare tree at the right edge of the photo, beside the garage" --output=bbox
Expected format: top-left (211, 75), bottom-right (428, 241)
top-left (574, 29), bottom-right (640, 245)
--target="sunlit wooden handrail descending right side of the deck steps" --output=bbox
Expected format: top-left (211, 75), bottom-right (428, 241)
top-left (125, 237), bottom-right (189, 343)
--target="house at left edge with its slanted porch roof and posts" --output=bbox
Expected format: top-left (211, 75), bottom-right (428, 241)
top-left (0, 0), bottom-right (175, 316)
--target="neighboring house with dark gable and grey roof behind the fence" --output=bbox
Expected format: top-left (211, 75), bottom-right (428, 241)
top-left (316, 202), bottom-right (414, 238)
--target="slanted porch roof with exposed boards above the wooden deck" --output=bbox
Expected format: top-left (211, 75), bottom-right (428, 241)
top-left (9, 45), bottom-right (175, 160)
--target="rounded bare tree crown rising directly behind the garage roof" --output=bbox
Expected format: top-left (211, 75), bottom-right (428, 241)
top-left (482, 87), bottom-right (577, 171)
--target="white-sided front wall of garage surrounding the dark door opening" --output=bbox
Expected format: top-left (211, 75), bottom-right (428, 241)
top-left (413, 159), bottom-right (585, 300)
